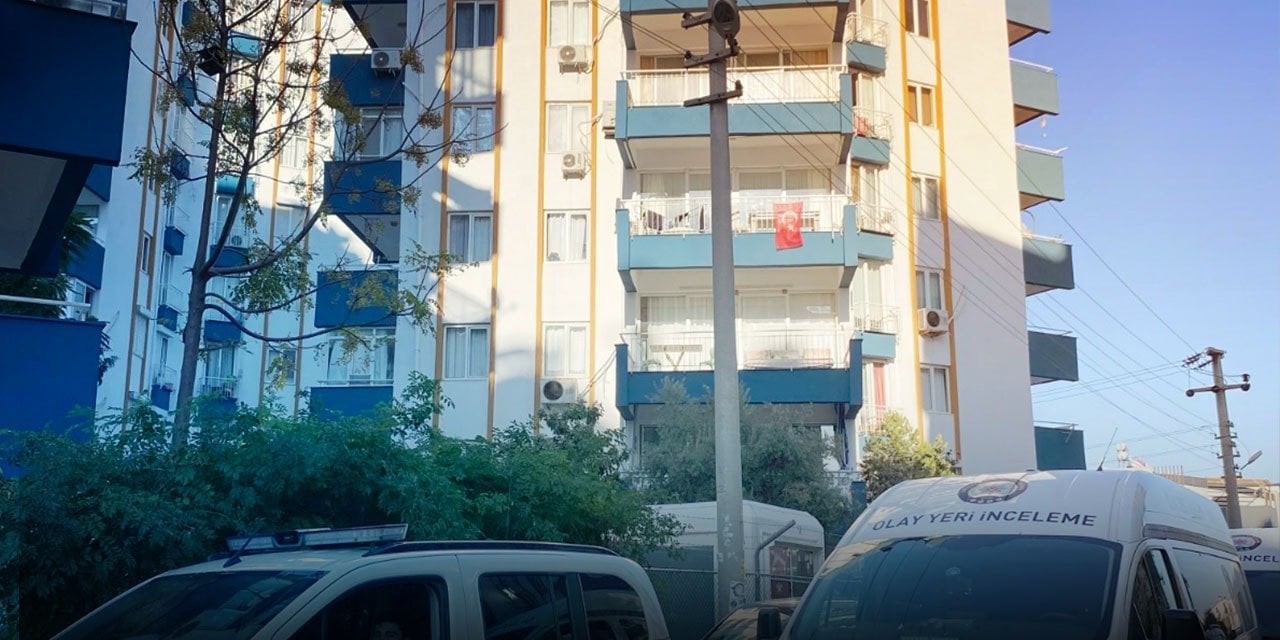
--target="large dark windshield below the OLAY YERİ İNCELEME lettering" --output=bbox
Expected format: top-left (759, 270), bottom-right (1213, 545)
top-left (790, 535), bottom-right (1120, 640)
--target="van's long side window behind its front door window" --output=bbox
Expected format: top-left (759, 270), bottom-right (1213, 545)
top-left (1174, 549), bottom-right (1256, 640)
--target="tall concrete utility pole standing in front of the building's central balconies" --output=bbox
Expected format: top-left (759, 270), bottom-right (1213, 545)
top-left (681, 0), bottom-right (746, 618)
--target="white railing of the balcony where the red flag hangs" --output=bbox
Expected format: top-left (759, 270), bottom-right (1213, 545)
top-left (622, 193), bottom-right (849, 236)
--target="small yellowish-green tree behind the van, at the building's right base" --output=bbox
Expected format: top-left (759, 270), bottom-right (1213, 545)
top-left (861, 412), bottom-right (956, 502)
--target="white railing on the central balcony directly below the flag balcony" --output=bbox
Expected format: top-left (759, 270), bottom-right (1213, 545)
top-left (623, 321), bottom-right (849, 371)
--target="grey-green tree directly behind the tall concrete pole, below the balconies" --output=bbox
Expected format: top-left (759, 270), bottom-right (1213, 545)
top-left (641, 380), bottom-right (852, 547)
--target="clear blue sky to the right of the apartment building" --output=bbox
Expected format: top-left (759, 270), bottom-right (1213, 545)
top-left (1011, 0), bottom-right (1280, 480)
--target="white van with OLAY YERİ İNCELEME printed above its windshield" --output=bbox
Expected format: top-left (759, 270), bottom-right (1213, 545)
top-left (785, 471), bottom-right (1260, 640)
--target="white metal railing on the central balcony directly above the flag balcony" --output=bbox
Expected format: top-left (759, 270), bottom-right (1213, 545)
top-left (622, 65), bottom-right (845, 106)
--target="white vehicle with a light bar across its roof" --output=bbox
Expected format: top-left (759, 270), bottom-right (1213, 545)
top-left (55, 525), bottom-right (667, 640)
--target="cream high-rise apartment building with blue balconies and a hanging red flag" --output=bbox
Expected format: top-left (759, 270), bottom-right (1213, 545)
top-left (312, 0), bottom-right (1076, 472)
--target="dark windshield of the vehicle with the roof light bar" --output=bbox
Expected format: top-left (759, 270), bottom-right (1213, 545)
top-left (58, 571), bottom-right (324, 640)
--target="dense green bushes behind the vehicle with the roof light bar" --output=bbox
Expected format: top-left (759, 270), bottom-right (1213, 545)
top-left (0, 376), bottom-right (678, 637)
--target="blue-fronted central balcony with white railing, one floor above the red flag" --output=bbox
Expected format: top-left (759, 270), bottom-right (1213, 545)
top-left (613, 65), bottom-right (870, 169)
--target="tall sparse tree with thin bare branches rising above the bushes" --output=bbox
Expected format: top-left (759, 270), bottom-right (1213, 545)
top-left (133, 0), bottom-right (476, 448)
